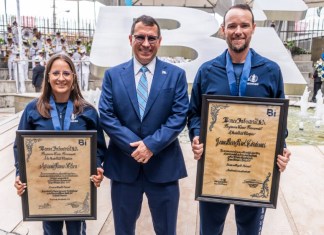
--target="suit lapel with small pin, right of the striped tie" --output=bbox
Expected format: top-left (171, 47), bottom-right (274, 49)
top-left (143, 58), bottom-right (168, 119)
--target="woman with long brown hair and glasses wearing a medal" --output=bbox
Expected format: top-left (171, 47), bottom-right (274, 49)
top-left (14, 54), bottom-right (106, 235)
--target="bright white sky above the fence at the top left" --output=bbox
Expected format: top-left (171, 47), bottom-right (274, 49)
top-left (0, 0), bottom-right (103, 20)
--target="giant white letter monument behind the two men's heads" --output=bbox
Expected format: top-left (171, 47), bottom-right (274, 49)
top-left (90, 0), bottom-right (307, 95)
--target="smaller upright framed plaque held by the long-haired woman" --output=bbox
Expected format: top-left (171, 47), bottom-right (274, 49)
top-left (17, 130), bottom-right (97, 221)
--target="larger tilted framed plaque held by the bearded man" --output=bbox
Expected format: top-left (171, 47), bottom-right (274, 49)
top-left (195, 95), bottom-right (288, 208)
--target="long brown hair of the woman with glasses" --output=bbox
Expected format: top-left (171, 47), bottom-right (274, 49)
top-left (37, 54), bottom-right (91, 118)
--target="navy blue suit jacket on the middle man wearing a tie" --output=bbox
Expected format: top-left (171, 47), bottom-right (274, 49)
top-left (99, 59), bottom-right (188, 183)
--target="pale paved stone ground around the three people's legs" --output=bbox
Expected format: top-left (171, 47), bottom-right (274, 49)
top-left (0, 111), bottom-right (324, 235)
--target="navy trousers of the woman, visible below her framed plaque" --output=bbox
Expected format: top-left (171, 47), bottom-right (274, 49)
top-left (43, 221), bottom-right (86, 235)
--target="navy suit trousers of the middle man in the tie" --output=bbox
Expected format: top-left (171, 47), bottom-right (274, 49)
top-left (111, 171), bottom-right (180, 235)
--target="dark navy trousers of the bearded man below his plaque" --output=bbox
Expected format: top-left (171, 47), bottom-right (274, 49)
top-left (199, 202), bottom-right (265, 235)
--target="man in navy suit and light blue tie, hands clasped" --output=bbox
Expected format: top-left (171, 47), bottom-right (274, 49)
top-left (99, 15), bottom-right (188, 235)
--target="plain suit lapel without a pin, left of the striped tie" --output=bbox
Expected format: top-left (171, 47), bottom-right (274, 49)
top-left (120, 60), bottom-right (140, 118)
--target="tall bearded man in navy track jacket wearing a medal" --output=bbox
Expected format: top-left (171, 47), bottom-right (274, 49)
top-left (188, 4), bottom-right (290, 235)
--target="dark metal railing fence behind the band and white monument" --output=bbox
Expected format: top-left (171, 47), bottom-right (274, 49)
top-left (0, 15), bottom-right (324, 58)
